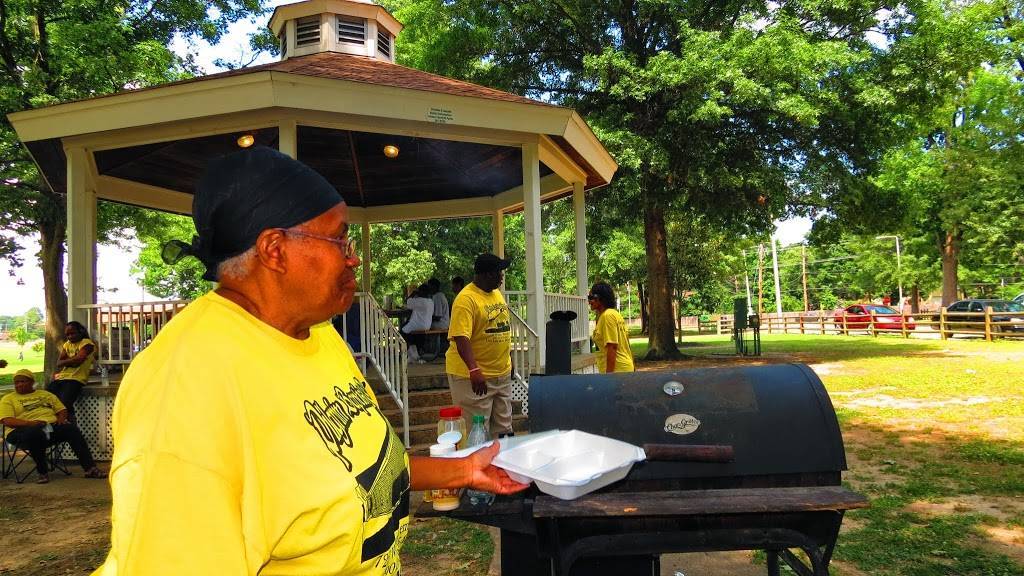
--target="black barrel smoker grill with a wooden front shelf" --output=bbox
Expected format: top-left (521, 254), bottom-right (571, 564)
top-left (418, 364), bottom-right (867, 576)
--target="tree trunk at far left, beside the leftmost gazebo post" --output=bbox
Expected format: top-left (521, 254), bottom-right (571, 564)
top-left (39, 214), bottom-right (68, 380)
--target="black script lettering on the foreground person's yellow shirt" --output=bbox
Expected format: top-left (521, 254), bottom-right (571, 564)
top-left (304, 379), bottom-right (383, 471)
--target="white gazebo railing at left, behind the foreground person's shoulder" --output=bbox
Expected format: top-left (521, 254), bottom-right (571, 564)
top-left (78, 300), bottom-right (188, 372)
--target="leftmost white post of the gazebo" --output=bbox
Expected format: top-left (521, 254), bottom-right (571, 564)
top-left (65, 148), bottom-right (96, 325)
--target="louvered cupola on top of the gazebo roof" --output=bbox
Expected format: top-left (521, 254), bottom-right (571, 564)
top-left (269, 0), bottom-right (402, 63)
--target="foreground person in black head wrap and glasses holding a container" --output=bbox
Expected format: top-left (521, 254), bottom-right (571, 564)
top-left (94, 147), bottom-right (526, 576)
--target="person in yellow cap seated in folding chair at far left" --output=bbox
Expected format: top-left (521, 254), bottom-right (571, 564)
top-left (0, 370), bottom-right (106, 484)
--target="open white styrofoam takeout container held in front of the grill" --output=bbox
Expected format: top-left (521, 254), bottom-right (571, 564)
top-left (493, 430), bottom-right (646, 500)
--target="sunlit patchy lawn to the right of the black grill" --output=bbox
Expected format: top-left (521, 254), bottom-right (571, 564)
top-left (632, 335), bottom-right (1024, 576)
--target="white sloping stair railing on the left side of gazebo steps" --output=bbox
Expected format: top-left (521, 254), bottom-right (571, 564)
top-left (357, 292), bottom-right (411, 448)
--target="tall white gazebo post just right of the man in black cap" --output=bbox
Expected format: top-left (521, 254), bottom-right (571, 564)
top-left (522, 142), bottom-right (547, 368)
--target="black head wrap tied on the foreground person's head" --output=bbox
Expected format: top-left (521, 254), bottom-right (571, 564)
top-left (162, 147), bottom-right (342, 281)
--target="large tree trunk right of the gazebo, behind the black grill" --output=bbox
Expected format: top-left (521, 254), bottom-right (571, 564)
top-left (643, 194), bottom-right (682, 360)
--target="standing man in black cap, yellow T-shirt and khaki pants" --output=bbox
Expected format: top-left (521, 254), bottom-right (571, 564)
top-left (444, 254), bottom-right (512, 438)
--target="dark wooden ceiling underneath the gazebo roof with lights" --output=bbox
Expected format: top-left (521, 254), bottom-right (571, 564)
top-left (88, 126), bottom-right (552, 207)
